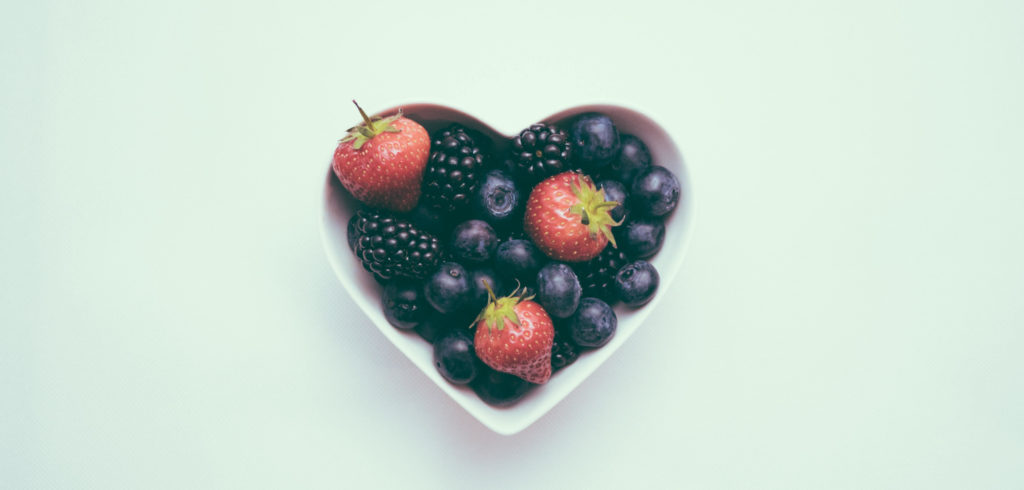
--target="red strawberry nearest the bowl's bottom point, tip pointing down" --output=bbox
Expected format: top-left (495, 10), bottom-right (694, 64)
top-left (473, 284), bottom-right (555, 384)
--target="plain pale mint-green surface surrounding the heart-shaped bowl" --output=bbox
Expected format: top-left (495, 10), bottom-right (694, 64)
top-left (0, 1), bottom-right (1024, 489)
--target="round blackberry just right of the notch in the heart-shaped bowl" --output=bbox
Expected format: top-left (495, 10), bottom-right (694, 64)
top-left (511, 123), bottom-right (572, 182)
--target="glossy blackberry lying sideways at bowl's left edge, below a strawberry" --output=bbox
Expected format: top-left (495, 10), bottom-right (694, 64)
top-left (350, 210), bottom-right (441, 282)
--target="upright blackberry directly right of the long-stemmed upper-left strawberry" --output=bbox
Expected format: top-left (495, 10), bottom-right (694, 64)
top-left (423, 125), bottom-right (484, 214)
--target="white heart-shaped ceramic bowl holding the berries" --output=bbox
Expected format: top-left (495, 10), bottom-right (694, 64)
top-left (322, 103), bottom-right (694, 435)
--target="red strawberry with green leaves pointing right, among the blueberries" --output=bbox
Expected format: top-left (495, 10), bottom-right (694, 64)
top-left (523, 172), bottom-right (622, 262)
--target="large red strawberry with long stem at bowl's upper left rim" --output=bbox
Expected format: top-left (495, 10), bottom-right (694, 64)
top-left (332, 100), bottom-right (430, 212)
